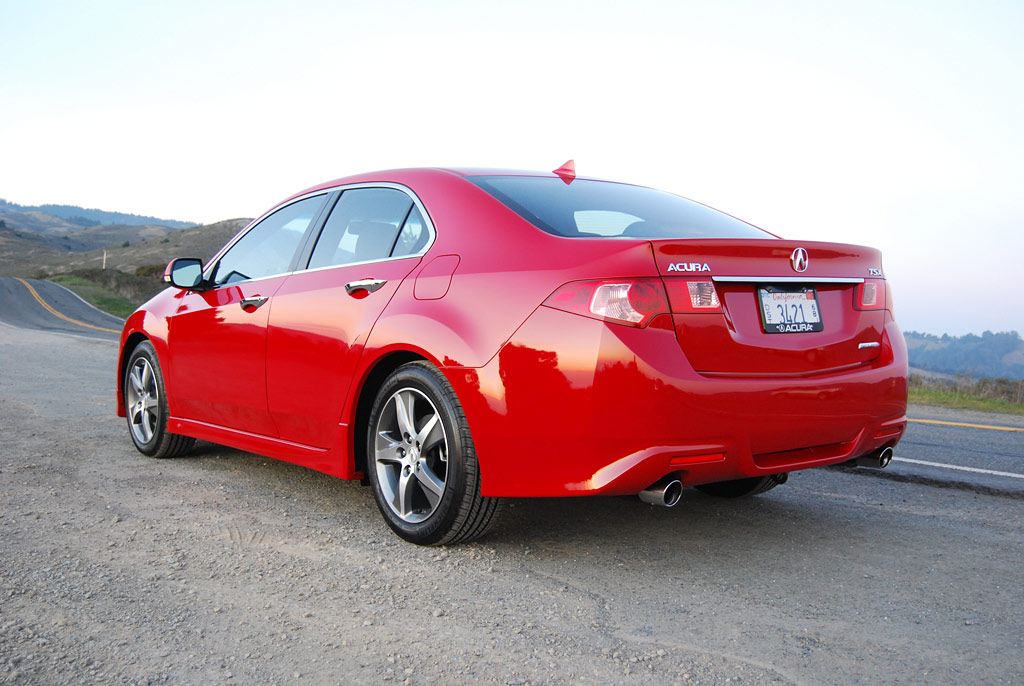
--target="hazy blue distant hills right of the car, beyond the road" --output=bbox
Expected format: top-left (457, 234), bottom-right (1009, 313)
top-left (904, 331), bottom-right (1024, 379)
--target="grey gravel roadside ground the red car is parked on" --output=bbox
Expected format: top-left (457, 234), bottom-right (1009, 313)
top-left (0, 326), bottom-right (1024, 684)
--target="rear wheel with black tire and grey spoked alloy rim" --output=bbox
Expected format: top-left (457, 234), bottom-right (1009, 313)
top-left (367, 361), bottom-right (502, 546)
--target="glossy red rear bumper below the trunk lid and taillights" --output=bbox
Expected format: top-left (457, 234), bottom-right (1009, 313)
top-left (445, 307), bottom-right (907, 497)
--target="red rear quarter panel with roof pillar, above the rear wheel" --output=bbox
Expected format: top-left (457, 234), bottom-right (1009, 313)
top-left (367, 172), bottom-right (657, 368)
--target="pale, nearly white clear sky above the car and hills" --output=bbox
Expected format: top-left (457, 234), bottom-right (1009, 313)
top-left (0, 0), bottom-right (1024, 335)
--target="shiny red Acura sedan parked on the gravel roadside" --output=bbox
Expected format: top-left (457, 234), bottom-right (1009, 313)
top-left (118, 164), bottom-right (907, 545)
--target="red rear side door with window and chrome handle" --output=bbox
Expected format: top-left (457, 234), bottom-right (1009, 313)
top-left (266, 186), bottom-right (433, 448)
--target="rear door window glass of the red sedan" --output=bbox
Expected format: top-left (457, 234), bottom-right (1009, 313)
top-left (309, 188), bottom-right (417, 269)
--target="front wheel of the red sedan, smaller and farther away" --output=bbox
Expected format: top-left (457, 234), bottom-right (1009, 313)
top-left (123, 341), bottom-right (196, 458)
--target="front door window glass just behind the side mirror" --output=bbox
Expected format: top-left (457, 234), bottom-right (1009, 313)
top-left (213, 195), bottom-right (327, 286)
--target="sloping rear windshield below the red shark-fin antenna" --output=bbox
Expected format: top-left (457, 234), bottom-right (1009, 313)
top-left (467, 176), bottom-right (773, 239)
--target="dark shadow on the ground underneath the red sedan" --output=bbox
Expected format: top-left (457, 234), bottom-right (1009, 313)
top-left (163, 441), bottom-right (887, 554)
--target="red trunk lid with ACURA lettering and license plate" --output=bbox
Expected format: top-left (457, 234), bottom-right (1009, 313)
top-left (651, 240), bottom-right (886, 376)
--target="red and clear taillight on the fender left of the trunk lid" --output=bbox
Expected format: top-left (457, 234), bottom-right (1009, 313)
top-left (544, 278), bottom-right (669, 327)
